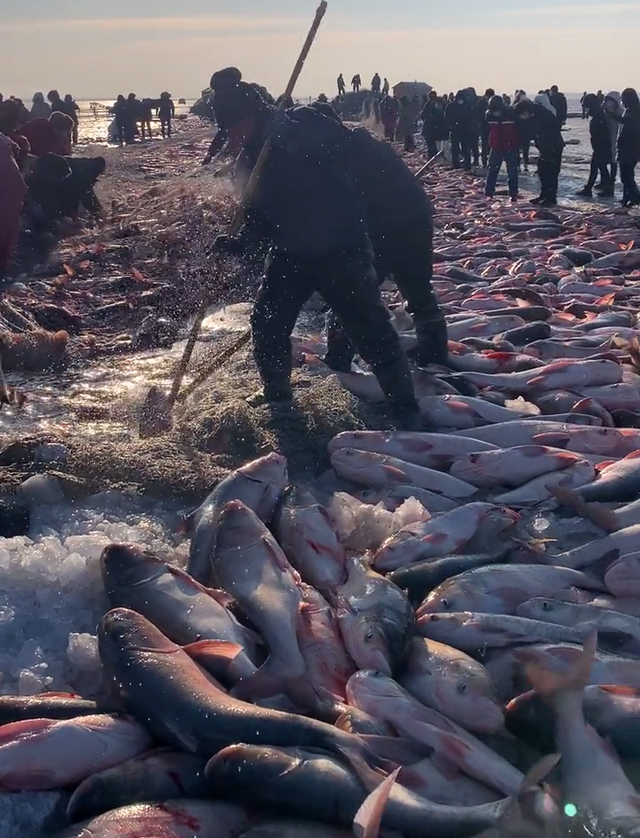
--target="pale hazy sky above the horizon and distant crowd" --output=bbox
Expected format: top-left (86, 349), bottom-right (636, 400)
top-left (0, 0), bottom-right (640, 99)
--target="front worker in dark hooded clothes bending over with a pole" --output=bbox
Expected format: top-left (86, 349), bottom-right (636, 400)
top-left (208, 82), bottom-right (422, 429)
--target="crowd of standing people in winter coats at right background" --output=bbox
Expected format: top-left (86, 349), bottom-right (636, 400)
top-left (338, 78), bottom-right (640, 207)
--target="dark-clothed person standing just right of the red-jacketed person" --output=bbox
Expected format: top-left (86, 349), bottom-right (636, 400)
top-left (515, 93), bottom-right (564, 207)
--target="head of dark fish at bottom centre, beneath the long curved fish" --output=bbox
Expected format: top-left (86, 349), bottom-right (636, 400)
top-left (205, 744), bottom-right (301, 795)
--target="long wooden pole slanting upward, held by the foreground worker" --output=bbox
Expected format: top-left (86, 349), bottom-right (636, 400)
top-left (168, 0), bottom-right (328, 408)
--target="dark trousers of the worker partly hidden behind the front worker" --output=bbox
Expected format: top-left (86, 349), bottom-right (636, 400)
top-left (325, 224), bottom-right (446, 369)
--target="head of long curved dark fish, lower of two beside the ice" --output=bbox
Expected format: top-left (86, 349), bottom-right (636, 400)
top-left (98, 608), bottom-right (180, 668)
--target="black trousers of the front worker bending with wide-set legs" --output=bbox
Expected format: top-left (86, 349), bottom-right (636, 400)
top-left (251, 246), bottom-right (413, 408)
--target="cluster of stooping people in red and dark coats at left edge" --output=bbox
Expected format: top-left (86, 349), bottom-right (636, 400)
top-left (0, 90), bottom-right (106, 281)
